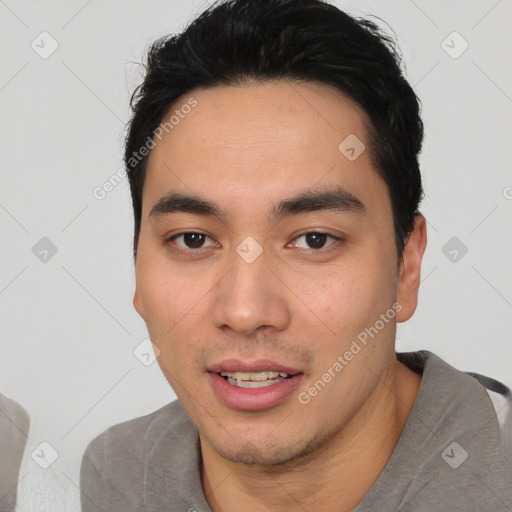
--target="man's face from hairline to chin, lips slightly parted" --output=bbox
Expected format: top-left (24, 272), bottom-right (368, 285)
top-left (134, 82), bottom-right (422, 464)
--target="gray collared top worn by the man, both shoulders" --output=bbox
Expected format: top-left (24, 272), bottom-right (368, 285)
top-left (80, 350), bottom-right (512, 512)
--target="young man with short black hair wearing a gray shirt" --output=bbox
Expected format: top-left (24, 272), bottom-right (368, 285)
top-left (81, 0), bottom-right (512, 512)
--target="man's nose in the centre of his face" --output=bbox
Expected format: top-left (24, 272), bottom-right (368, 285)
top-left (212, 240), bottom-right (291, 336)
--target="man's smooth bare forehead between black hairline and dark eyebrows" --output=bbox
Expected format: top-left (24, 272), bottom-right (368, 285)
top-left (143, 81), bottom-right (387, 221)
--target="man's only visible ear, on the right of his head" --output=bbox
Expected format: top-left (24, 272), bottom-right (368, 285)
top-left (396, 214), bottom-right (427, 322)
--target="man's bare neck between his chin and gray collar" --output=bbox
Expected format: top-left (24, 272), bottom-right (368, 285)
top-left (201, 355), bottom-right (421, 512)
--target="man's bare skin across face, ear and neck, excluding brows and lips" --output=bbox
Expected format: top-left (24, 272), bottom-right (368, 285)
top-left (134, 81), bottom-right (426, 512)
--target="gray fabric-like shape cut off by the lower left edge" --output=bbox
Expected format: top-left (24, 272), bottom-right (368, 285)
top-left (0, 393), bottom-right (30, 512)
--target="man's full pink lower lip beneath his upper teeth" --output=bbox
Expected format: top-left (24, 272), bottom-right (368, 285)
top-left (208, 372), bottom-right (304, 411)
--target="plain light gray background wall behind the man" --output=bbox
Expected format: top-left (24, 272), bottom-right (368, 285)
top-left (0, 0), bottom-right (512, 512)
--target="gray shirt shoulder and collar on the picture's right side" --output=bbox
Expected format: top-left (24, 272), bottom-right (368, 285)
top-left (388, 351), bottom-right (512, 512)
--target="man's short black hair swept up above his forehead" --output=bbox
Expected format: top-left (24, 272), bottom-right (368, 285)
top-left (124, 0), bottom-right (423, 260)
